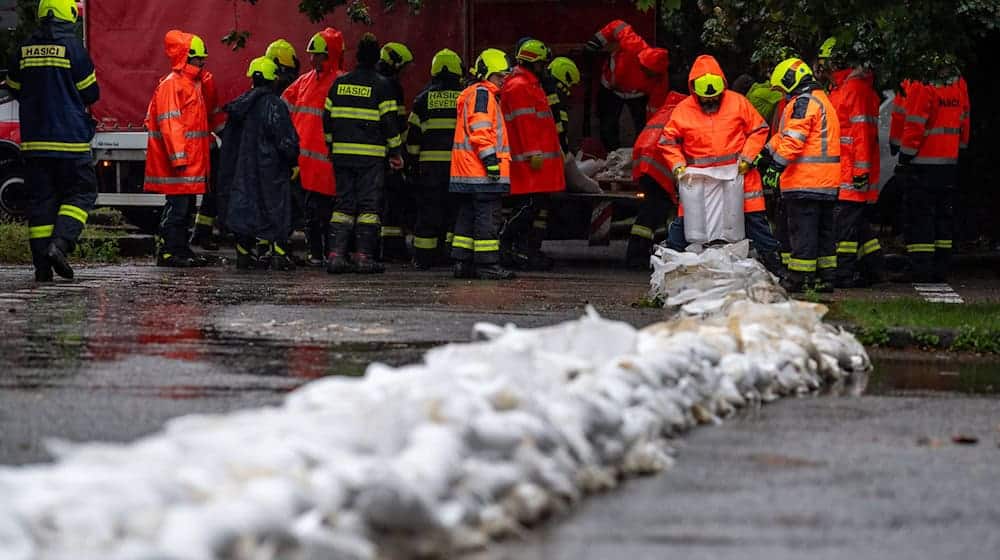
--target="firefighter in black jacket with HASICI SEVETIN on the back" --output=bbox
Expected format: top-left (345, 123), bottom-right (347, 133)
top-left (406, 49), bottom-right (463, 269)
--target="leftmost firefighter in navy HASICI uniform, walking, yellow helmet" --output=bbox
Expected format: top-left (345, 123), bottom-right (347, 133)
top-left (7, 0), bottom-right (100, 282)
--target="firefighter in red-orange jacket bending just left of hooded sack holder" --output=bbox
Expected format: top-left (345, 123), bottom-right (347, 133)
top-left (625, 91), bottom-right (687, 268)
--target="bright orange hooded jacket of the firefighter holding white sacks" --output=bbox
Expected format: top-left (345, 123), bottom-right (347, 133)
top-left (660, 55), bottom-right (768, 212)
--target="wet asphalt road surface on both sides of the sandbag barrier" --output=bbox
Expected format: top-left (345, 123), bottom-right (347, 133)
top-left (0, 244), bottom-right (1000, 560)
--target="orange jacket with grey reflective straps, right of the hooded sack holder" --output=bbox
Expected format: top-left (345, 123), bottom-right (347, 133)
top-left (768, 85), bottom-right (841, 200)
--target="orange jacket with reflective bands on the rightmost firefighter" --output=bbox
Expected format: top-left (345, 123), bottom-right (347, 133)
top-left (899, 78), bottom-right (970, 165)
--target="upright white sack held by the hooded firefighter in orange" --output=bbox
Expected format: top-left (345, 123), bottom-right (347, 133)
top-left (680, 163), bottom-right (746, 245)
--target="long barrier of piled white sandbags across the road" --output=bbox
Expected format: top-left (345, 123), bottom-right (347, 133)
top-left (0, 245), bottom-right (871, 560)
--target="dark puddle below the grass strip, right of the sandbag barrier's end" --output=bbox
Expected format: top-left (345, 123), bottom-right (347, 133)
top-left (865, 350), bottom-right (1000, 396)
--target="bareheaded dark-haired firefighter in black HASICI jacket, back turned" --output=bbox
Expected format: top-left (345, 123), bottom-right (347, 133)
top-left (323, 33), bottom-right (403, 274)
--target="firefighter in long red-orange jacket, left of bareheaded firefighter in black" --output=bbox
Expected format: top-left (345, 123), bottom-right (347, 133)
top-left (281, 27), bottom-right (344, 266)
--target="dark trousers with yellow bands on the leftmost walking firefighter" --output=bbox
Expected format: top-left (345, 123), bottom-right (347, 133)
top-left (25, 156), bottom-right (97, 269)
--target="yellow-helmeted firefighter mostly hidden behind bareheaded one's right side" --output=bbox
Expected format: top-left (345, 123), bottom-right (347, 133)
top-left (375, 42), bottom-right (413, 261)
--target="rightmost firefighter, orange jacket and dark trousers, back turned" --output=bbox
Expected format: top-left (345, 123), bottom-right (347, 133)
top-left (899, 56), bottom-right (970, 282)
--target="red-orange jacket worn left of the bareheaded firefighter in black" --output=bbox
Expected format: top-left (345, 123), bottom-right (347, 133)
top-left (281, 27), bottom-right (344, 196)
